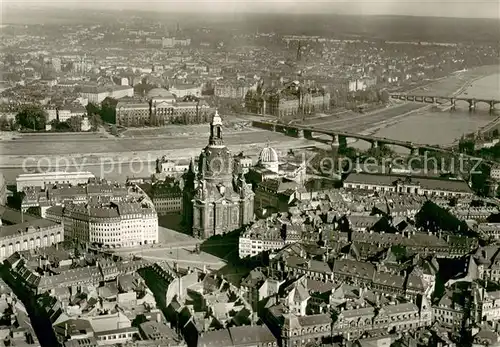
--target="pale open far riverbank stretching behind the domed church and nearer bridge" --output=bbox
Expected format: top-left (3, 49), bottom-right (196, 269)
top-left (0, 66), bottom-right (499, 177)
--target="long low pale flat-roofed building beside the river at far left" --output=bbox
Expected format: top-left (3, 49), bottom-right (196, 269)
top-left (16, 172), bottom-right (95, 192)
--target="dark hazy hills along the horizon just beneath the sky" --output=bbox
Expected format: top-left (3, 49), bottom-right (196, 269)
top-left (2, 7), bottom-right (500, 44)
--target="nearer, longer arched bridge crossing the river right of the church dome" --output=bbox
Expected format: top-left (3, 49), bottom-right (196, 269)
top-left (252, 121), bottom-right (495, 165)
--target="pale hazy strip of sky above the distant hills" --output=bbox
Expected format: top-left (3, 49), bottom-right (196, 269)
top-left (0, 0), bottom-right (500, 19)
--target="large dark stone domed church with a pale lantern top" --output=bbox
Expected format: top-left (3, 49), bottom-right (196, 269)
top-left (183, 110), bottom-right (254, 239)
